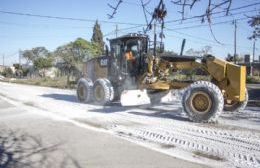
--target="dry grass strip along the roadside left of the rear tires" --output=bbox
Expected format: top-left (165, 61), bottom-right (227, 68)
top-left (10, 76), bottom-right (75, 89)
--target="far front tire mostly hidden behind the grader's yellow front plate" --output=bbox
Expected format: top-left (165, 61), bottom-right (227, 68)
top-left (224, 89), bottom-right (248, 112)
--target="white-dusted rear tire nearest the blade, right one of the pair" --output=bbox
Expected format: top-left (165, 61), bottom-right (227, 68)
top-left (93, 78), bottom-right (114, 105)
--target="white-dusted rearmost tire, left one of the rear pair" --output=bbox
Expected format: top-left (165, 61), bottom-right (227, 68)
top-left (77, 78), bottom-right (93, 103)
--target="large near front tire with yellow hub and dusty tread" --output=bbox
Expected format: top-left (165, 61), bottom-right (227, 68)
top-left (182, 81), bottom-right (224, 123)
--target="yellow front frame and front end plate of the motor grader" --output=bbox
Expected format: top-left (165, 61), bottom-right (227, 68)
top-left (142, 57), bottom-right (246, 102)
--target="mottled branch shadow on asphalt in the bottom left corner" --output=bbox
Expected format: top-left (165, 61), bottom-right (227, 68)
top-left (0, 129), bottom-right (81, 168)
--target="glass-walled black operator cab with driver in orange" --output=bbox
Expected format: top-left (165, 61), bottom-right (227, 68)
top-left (108, 33), bottom-right (148, 83)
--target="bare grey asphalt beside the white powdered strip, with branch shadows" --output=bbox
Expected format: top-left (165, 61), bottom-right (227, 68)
top-left (0, 98), bottom-right (206, 168)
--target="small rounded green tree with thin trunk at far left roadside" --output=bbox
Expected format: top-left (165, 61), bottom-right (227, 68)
top-left (33, 57), bottom-right (53, 77)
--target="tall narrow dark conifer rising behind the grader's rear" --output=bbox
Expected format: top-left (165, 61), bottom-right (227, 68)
top-left (91, 21), bottom-right (105, 54)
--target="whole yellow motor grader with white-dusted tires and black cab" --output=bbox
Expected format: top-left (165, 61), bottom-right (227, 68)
top-left (77, 33), bottom-right (248, 122)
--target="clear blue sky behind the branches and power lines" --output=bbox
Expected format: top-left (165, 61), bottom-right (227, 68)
top-left (0, 0), bottom-right (260, 65)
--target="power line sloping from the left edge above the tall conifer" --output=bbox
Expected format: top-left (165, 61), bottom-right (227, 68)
top-left (0, 10), bottom-right (145, 26)
